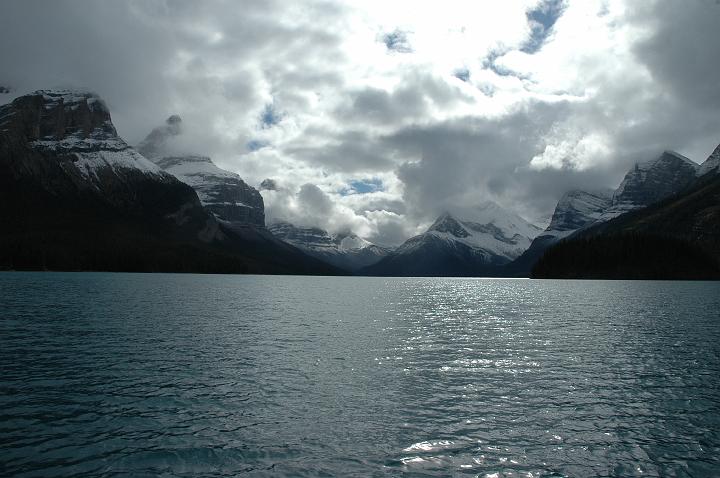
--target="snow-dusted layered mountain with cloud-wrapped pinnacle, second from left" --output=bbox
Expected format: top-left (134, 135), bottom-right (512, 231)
top-left (138, 115), bottom-right (265, 227)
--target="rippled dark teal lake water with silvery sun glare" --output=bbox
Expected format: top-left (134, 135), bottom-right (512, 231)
top-left (0, 273), bottom-right (720, 477)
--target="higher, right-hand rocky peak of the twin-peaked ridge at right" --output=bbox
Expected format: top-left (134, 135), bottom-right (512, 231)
top-left (601, 151), bottom-right (699, 220)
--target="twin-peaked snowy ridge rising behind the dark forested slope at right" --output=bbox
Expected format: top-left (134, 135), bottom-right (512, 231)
top-left (506, 151), bottom-right (700, 276)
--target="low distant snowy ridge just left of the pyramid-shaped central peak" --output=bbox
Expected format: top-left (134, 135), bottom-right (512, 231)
top-left (268, 222), bottom-right (389, 272)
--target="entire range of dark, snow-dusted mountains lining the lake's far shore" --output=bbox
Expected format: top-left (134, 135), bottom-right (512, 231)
top-left (0, 90), bottom-right (720, 278)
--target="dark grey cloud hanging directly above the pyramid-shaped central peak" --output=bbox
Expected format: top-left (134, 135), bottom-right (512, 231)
top-left (387, 103), bottom-right (570, 220)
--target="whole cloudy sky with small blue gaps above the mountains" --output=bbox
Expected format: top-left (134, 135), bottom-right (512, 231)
top-left (0, 0), bottom-right (720, 244)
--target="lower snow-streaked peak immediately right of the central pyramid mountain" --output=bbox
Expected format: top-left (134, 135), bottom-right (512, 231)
top-left (506, 190), bottom-right (613, 276)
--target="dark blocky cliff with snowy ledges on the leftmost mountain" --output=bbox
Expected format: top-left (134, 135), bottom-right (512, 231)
top-left (0, 90), bottom-right (199, 214)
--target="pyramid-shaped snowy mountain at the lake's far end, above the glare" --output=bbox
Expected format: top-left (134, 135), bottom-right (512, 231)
top-left (361, 202), bottom-right (540, 276)
